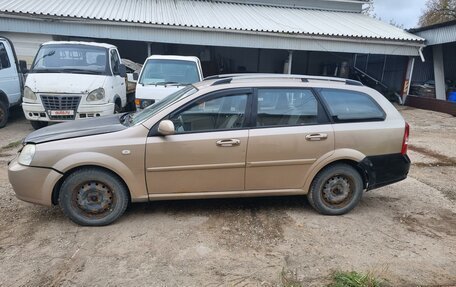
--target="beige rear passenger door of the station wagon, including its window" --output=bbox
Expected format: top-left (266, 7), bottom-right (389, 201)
top-left (246, 88), bottom-right (334, 190)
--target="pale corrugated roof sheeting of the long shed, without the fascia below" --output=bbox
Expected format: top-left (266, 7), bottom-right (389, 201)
top-left (0, 0), bottom-right (424, 42)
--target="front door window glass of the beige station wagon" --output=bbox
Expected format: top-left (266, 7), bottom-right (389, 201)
top-left (169, 94), bottom-right (248, 134)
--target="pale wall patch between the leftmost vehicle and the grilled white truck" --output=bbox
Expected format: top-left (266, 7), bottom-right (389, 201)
top-left (0, 31), bottom-right (52, 68)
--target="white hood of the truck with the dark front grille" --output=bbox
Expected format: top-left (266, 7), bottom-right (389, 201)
top-left (25, 73), bottom-right (106, 94)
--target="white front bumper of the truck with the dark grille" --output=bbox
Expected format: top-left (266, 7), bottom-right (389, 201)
top-left (22, 103), bottom-right (114, 122)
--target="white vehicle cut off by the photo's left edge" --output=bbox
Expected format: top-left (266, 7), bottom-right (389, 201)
top-left (0, 37), bottom-right (27, 128)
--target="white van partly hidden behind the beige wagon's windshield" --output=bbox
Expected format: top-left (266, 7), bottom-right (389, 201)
top-left (136, 55), bottom-right (203, 109)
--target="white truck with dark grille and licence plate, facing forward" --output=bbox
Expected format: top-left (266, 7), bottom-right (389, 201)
top-left (22, 41), bottom-right (134, 129)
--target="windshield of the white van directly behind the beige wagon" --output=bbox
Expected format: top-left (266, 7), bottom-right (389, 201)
top-left (139, 59), bottom-right (200, 86)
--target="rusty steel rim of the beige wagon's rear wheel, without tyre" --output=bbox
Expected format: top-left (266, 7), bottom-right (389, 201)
top-left (321, 174), bottom-right (355, 208)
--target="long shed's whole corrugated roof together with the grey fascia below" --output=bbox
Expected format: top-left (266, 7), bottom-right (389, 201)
top-left (0, 0), bottom-right (424, 56)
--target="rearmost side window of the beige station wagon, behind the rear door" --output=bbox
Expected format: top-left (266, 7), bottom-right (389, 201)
top-left (320, 89), bottom-right (385, 122)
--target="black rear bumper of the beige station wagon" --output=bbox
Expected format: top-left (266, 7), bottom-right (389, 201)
top-left (359, 154), bottom-right (411, 190)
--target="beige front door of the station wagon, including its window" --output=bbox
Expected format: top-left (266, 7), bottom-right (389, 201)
top-left (146, 89), bottom-right (252, 194)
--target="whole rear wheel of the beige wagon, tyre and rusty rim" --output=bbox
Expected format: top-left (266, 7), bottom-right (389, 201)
top-left (307, 164), bottom-right (363, 215)
